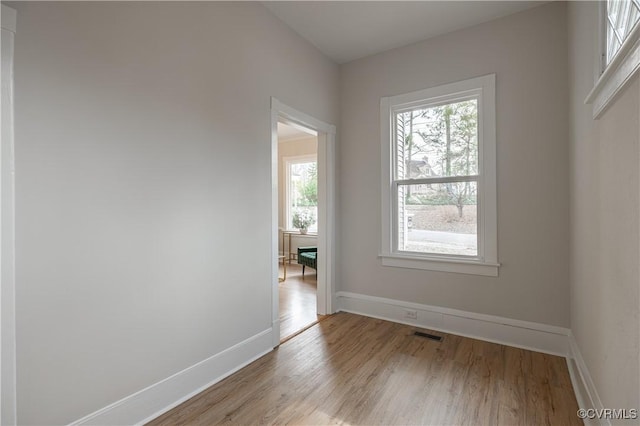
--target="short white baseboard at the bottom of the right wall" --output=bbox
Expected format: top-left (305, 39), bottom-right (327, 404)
top-left (567, 333), bottom-right (611, 426)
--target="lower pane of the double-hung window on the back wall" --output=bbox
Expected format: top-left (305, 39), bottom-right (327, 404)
top-left (398, 182), bottom-right (478, 256)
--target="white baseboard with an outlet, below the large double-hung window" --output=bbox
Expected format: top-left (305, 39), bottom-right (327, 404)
top-left (337, 292), bottom-right (570, 357)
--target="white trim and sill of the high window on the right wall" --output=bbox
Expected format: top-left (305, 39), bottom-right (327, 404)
top-left (584, 2), bottom-right (640, 119)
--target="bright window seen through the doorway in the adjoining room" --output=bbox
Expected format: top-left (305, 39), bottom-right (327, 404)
top-left (284, 155), bottom-right (318, 232)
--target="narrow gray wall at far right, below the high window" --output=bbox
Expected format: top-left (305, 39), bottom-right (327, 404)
top-left (568, 2), bottom-right (640, 418)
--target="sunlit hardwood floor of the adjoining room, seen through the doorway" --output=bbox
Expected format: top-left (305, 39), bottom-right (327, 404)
top-left (279, 263), bottom-right (322, 341)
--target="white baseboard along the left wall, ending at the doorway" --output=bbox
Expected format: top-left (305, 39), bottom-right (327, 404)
top-left (71, 329), bottom-right (273, 425)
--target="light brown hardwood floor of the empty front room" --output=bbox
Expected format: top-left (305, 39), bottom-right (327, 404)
top-left (149, 313), bottom-right (582, 426)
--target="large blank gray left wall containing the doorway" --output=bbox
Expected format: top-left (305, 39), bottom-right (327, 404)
top-left (11, 3), bottom-right (339, 424)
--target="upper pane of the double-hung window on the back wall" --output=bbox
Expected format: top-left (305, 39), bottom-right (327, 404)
top-left (396, 99), bottom-right (478, 180)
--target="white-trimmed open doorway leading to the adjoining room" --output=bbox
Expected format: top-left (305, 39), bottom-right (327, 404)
top-left (271, 98), bottom-right (335, 347)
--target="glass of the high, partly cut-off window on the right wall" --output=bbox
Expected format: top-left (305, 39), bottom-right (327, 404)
top-left (605, 0), bottom-right (640, 64)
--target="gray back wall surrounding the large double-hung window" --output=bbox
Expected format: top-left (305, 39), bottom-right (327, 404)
top-left (338, 3), bottom-right (569, 327)
